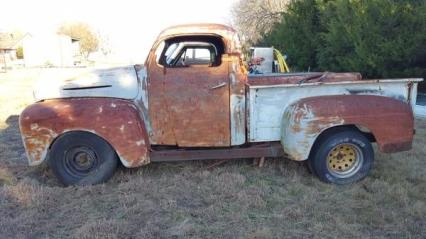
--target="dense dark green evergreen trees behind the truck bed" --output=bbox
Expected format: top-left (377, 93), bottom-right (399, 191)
top-left (255, 0), bottom-right (426, 78)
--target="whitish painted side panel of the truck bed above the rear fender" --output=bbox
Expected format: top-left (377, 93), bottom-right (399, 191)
top-left (248, 76), bottom-right (416, 142)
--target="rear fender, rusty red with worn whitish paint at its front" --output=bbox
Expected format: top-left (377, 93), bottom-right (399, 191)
top-left (281, 95), bottom-right (414, 161)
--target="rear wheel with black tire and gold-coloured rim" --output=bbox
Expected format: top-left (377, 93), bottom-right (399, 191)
top-left (308, 128), bottom-right (374, 185)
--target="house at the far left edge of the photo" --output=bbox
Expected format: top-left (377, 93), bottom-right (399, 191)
top-left (0, 32), bottom-right (29, 69)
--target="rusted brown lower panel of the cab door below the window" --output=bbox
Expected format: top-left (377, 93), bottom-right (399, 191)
top-left (163, 58), bottom-right (231, 147)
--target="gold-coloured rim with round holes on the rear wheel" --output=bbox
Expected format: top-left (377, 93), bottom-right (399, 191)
top-left (327, 143), bottom-right (364, 178)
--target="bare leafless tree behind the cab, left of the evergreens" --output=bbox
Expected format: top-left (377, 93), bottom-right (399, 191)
top-left (232, 0), bottom-right (289, 44)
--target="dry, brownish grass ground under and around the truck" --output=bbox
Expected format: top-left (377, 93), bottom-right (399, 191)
top-left (0, 70), bottom-right (426, 238)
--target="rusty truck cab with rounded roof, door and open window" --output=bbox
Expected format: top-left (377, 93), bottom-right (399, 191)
top-left (146, 25), bottom-right (246, 147)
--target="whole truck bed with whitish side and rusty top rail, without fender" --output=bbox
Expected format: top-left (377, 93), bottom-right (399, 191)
top-left (247, 73), bottom-right (422, 142)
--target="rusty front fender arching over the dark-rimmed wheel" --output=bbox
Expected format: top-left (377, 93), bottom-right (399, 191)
top-left (19, 98), bottom-right (150, 167)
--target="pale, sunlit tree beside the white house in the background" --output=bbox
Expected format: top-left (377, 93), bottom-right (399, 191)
top-left (58, 23), bottom-right (99, 60)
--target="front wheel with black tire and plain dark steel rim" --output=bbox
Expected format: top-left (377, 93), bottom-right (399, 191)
top-left (49, 131), bottom-right (118, 186)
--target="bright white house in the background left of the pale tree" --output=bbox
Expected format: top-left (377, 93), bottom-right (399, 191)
top-left (23, 33), bottom-right (81, 67)
